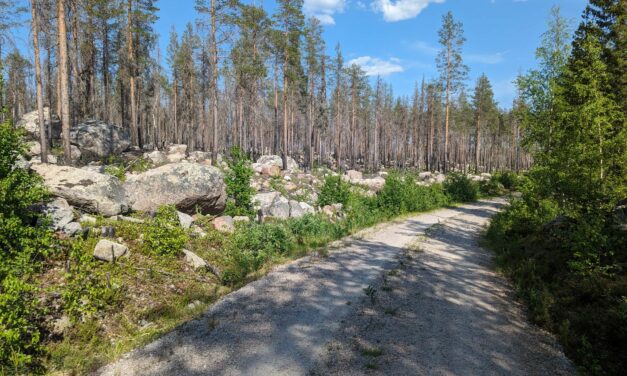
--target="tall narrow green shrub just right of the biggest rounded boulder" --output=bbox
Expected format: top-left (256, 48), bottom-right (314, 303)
top-left (224, 147), bottom-right (255, 216)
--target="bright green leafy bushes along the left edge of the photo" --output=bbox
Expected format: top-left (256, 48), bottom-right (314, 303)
top-left (0, 114), bottom-right (55, 374)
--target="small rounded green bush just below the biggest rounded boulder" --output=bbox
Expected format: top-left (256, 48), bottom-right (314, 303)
top-left (144, 205), bottom-right (188, 256)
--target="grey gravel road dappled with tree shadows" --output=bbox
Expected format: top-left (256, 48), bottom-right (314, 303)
top-left (98, 200), bottom-right (573, 375)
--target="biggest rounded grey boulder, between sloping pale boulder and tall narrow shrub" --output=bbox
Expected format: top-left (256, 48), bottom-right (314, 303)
top-left (124, 163), bottom-right (226, 214)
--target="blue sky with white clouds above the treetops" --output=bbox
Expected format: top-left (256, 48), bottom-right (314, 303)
top-left (9, 0), bottom-right (587, 108)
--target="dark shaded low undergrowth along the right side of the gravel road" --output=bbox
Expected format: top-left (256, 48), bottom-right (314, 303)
top-left (486, 194), bottom-right (627, 375)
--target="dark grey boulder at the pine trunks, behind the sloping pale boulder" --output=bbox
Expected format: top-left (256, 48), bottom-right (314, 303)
top-left (70, 120), bottom-right (131, 160)
